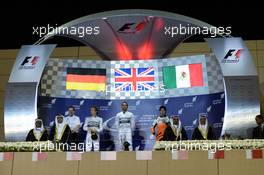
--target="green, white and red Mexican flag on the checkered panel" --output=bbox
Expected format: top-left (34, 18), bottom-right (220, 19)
top-left (162, 63), bottom-right (204, 89)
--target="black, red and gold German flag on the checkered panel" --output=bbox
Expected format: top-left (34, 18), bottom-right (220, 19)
top-left (66, 68), bottom-right (106, 91)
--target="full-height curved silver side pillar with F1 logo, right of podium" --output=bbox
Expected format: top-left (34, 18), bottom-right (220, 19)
top-left (206, 38), bottom-right (260, 138)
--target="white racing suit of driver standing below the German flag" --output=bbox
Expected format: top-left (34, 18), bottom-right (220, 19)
top-left (83, 116), bottom-right (103, 151)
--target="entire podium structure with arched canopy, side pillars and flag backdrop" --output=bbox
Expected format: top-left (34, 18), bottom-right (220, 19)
top-left (4, 10), bottom-right (260, 150)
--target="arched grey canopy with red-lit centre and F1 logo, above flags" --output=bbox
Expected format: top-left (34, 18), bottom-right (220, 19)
top-left (37, 10), bottom-right (221, 60)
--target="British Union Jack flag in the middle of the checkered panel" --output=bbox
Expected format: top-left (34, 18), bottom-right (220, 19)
top-left (115, 67), bottom-right (155, 91)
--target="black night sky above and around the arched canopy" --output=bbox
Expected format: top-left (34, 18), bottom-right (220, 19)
top-left (0, 0), bottom-right (264, 49)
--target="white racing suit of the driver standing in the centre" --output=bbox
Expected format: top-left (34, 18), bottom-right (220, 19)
top-left (115, 111), bottom-right (135, 151)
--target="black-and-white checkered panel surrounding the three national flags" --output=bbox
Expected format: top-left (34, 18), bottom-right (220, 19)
top-left (41, 55), bottom-right (224, 99)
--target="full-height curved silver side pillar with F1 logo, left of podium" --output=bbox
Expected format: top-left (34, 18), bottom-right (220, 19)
top-left (4, 44), bottom-right (56, 141)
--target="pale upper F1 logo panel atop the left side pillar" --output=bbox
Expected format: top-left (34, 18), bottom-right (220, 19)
top-left (8, 44), bottom-right (56, 83)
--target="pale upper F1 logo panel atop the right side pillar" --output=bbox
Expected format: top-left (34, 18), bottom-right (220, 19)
top-left (206, 38), bottom-right (257, 76)
